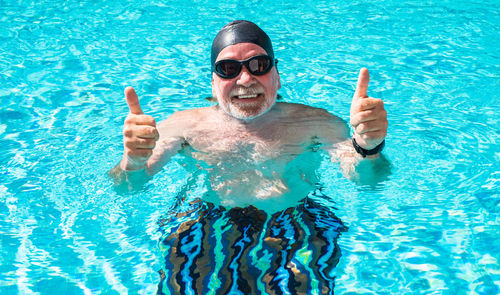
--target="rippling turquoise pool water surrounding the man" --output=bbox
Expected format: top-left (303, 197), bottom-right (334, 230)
top-left (0, 1), bottom-right (500, 294)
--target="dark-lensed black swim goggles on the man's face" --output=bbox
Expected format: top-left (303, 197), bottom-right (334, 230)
top-left (214, 55), bottom-right (278, 79)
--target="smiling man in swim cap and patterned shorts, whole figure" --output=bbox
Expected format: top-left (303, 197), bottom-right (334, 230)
top-left (110, 21), bottom-right (387, 294)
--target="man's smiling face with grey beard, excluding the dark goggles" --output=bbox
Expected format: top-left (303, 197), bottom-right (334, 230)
top-left (212, 43), bottom-right (281, 120)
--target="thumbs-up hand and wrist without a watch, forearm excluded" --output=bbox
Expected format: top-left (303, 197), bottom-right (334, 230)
top-left (120, 86), bottom-right (159, 170)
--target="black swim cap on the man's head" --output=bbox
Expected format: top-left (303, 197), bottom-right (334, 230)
top-left (212, 20), bottom-right (274, 70)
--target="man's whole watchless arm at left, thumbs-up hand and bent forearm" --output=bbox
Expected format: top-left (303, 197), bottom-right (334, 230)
top-left (109, 87), bottom-right (184, 185)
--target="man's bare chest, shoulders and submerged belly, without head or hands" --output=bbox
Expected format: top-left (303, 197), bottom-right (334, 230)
top-left (159, 103), bottom-right (347, 211)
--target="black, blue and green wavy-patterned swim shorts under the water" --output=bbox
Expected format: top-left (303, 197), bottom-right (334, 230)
top-left (158, 190), bottom-right (347, 294)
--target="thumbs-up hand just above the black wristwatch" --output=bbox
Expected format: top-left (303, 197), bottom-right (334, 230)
top-left (351, 68), bottom-right (388, 150)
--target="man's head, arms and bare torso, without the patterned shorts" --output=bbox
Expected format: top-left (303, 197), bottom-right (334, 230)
top-left (111, 21), bottom-right (388, 211)
